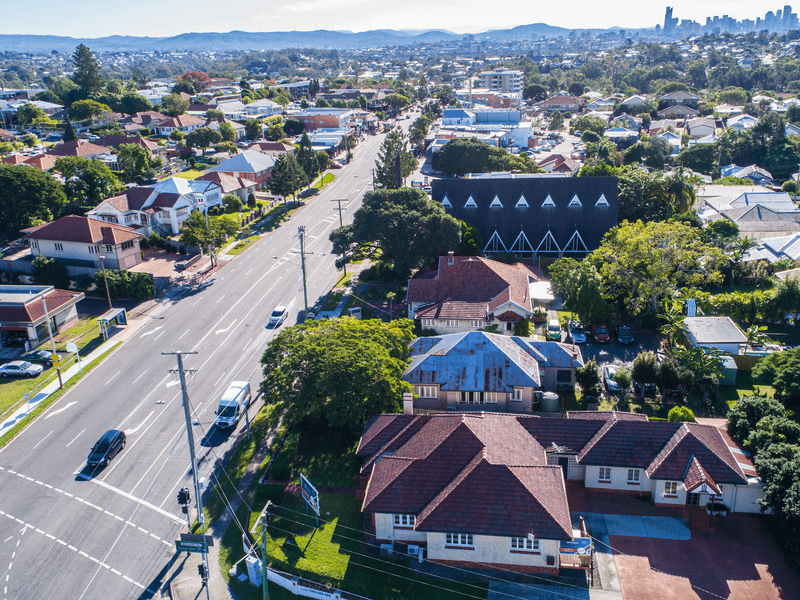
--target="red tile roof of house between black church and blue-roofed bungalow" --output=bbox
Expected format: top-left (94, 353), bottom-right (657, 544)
top-left (406, 256), bottom-right (539, 319)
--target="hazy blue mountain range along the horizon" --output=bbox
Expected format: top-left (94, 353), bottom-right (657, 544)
top-left (0, 23), bottom-right (644, 53)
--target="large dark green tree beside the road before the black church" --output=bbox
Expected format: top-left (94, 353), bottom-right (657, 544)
top-left (330, 188), bottom-right (461, 277)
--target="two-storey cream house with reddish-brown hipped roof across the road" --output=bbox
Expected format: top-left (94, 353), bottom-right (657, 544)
top-left (23, 215), bottom-right (142, 275)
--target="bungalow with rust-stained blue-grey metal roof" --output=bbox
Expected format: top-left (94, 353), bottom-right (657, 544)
top-left (403, 331), bottom-right (583, 413)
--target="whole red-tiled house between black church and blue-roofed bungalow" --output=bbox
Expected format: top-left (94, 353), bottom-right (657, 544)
top-left (406, 252), bottom-right (539, 334)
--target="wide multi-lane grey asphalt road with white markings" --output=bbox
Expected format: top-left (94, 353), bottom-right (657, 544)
top-left (0, 120), bottom-right (398, 600)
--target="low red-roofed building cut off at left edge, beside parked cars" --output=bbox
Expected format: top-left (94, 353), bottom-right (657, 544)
top-left (0, 285), bottom-right (84, 351)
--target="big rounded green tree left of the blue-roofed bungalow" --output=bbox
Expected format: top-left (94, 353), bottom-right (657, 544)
top-left (260, 318), bottom-right (413, 432)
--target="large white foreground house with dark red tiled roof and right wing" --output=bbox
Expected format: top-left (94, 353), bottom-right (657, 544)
top-left (356, 412), bottom-right (762, 575)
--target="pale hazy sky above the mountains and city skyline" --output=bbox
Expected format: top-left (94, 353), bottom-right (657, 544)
top-left (0, 0), bottom-right (788, 38)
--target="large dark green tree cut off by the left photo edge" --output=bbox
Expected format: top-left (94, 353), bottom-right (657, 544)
top-left (0, 164), bottom-right (67, 235)
